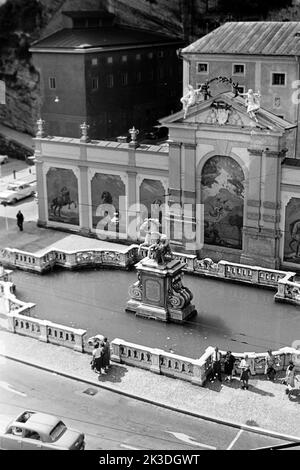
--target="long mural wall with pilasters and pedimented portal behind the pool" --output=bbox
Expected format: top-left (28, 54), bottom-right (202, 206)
top-left (36, 85), bottom-right (300, 269)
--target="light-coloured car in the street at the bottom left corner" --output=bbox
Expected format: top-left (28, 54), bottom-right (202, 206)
top-left (0, 411), bottom-right (85, 450)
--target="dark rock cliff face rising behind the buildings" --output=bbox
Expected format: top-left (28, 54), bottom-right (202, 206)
top-left (0, 0), bottom-right (300, 135)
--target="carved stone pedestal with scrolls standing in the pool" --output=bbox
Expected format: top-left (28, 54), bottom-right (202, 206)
top-left (126, 257), bottom-right (197, 323)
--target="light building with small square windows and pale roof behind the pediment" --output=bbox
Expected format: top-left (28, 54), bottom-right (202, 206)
top-left (182, 21), bottom-right (300, 158)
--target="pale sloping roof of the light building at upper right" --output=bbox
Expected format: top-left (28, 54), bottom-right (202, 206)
top-left (182, 21), bottom-right (300, 56)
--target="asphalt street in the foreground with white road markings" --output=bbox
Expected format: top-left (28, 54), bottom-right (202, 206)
top-left (0, 358), bottom-right (292, 452)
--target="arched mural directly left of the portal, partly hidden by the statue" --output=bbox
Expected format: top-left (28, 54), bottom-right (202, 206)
top-left (140, 179), bottom-right (166, 232)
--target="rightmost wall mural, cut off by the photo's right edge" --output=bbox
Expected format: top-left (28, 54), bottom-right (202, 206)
top-left (284, 197), bottom-right (300, 264)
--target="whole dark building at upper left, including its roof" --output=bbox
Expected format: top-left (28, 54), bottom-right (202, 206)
top-left (30, 12), bottom-right (182, 139)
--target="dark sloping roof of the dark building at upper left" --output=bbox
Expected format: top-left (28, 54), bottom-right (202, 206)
top-left (31, 26), bottom-right (182, 51)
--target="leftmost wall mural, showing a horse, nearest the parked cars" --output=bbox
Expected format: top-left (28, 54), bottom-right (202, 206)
top-left (46, 167), bottom-right (79, 225)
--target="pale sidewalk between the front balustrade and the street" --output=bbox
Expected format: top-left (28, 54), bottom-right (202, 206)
top-left (0, 331), bottom-right (300, 439)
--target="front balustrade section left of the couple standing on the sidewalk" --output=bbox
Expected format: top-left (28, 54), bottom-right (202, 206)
top-left (7, 312), bottom-right (86, 352)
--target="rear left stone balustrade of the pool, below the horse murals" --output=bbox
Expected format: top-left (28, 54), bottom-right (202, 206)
top-left (0, 245), bottom-right (137, 273)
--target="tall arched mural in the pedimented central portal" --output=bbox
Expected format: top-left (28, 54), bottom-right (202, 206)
top-left (201, 155), bottom-right (244, 249)
